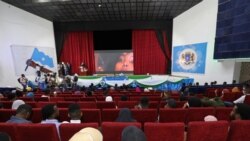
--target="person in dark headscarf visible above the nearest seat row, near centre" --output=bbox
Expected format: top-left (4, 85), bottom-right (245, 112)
top-left (115, 108), bottom-right (136, 122)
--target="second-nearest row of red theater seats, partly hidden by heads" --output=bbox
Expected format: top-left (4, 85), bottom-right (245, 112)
top-left (0, 107), bottom-right (232, 123)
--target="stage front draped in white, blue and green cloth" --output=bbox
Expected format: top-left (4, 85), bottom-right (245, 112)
top-left (77, 75), bottom-right (194, 90)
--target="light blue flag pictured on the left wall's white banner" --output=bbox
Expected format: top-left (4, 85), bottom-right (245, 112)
top-left (31, 48), bottom-right (54, 68)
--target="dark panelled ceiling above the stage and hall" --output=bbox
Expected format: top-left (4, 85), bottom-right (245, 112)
top-left (2, 0), bottom-right (202, 22)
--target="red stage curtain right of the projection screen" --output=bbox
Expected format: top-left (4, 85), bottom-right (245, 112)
top-left (132, 30), bottom-right (167, 74)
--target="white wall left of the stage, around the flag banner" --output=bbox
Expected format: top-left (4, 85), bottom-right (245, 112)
top-left (0, 1), bottom-right (56, 87)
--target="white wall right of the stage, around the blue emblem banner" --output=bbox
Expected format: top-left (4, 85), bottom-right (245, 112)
top-left (172, 0), bottom-right (239, 84)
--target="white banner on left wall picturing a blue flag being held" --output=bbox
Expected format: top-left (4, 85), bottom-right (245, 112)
top-left (11, 45), bottom-right (57, 75)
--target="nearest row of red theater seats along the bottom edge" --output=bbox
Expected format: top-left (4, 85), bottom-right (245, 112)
top-left (0, 121), bottom-right (250, 141)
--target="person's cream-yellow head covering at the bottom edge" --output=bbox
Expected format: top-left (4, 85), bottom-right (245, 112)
top-left (69, 127), bottom-right (103, 141)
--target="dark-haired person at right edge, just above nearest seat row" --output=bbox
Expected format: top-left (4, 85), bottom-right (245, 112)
top-left (230, 103), bottom-right (250, 120)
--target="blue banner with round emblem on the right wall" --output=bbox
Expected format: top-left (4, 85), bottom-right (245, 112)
top-left (172, 43), bottom-right (207, 74)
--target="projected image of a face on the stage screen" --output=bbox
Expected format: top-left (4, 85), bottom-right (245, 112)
top-left (95, 50), bottom-right (134, 73)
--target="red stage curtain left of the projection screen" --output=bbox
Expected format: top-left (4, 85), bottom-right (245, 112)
top-left (60, 32), bottom-right (95, 74)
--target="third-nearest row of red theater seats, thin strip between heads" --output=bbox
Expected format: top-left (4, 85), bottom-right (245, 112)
top-left (2, 101), bottom-right (186, 109)
